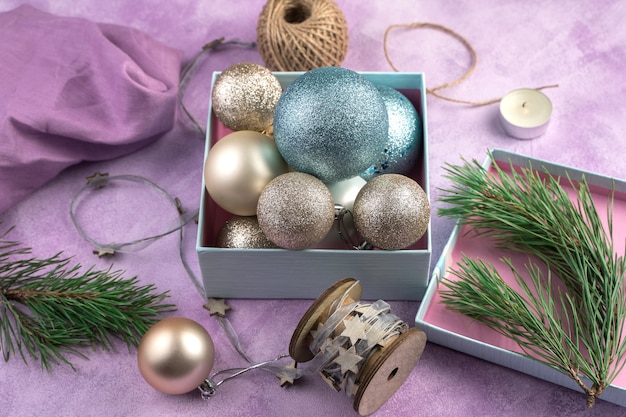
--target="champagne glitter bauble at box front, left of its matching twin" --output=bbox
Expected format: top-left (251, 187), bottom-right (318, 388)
top-left (257, 172), bottom-right (335, 249)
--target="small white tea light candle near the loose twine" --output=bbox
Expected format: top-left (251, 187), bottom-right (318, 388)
top-left (500, 88), bottom-right (552, 139)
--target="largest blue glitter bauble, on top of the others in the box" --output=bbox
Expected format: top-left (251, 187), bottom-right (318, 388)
top-left (274, 67), bottom-right (389, 183)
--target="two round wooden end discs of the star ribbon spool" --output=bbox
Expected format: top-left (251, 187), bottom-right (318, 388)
top-left (289, 278), bottom-right (426, 416)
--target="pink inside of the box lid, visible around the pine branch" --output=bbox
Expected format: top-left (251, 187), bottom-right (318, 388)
top-left (424, 159), bottom-right (626, 387)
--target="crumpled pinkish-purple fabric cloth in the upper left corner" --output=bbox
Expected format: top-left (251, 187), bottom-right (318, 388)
top-left (0, 6), bottom-right (181, 213)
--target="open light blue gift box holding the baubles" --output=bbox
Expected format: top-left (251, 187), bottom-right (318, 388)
top-left (196, 72), bottom-right (431, 300)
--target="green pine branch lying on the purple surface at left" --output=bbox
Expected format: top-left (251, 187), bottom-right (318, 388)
top-left (0, 229), bottom-right (173, 369)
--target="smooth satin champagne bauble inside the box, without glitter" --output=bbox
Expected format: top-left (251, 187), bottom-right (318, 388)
top-left (204, 130), bottom-right (289, 216)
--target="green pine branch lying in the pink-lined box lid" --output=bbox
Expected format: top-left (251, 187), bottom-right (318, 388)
top-left (439, 154), bottom-right (626, 406)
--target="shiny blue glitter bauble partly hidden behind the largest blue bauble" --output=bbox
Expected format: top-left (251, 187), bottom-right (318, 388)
top-left (361, 85), bottom-right (422, 181)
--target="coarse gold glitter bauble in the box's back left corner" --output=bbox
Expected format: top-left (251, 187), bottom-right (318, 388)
top-left (211, 63), bottom-right (282, 132)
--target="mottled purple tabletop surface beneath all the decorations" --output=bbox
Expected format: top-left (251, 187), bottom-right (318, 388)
top-left (0, 0), bottom-right (626, 417)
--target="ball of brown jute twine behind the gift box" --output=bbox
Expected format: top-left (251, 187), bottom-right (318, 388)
top-left (257, 0), bottom-right (348, 71)
